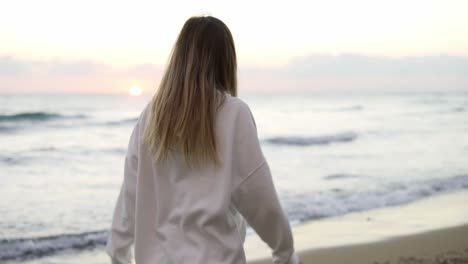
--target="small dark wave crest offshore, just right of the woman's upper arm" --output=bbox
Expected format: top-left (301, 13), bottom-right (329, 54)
top-left (265, 132), bottom-right (358, 146)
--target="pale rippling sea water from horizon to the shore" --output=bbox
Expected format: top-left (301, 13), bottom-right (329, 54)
top-left (0, 92), bottom-right (468, 263)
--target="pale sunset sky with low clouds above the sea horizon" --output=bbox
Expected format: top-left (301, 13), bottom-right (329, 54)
top-left (0, 0), bottom-right (468, 93)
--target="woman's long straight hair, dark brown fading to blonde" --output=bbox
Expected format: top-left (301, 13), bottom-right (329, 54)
top-left (144, 16), bottom-right (237, 165)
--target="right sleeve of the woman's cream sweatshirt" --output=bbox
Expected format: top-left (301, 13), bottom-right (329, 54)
top-left (233, 104), bottom-right (299, 264)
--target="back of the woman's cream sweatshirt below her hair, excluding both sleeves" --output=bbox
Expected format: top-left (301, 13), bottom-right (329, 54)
top-left (136, 97), bottom-right (252, 263)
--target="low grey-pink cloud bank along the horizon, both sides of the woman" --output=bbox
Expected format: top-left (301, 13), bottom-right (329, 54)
top-left (0, 54), bottom-right (468, 93)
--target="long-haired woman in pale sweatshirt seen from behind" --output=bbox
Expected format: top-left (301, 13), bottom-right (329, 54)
top-left (106, 16), bottom-right (298, 264)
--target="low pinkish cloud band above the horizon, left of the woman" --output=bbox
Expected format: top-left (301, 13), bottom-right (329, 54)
top-left (0, 57), bottom-right (162, 93)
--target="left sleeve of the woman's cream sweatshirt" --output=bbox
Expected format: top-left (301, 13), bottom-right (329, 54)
top-left (106, 122), bottom-right (139, 264)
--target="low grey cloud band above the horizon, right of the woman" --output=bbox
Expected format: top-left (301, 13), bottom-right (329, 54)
top-left (240, 54), bottom-right (468, 91)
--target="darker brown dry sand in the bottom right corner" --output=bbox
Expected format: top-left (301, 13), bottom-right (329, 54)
top-left (249, 224), bottom-right (468, 264)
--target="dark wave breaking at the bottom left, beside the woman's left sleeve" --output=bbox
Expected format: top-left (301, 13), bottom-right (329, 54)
top-left (0, 231), bottom-right (107, 261)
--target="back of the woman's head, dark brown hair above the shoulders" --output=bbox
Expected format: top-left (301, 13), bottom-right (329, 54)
top-left (169, 16), bottom-right (237, 95)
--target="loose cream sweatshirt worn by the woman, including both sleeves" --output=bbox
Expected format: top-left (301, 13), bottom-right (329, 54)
top-left (106, 95), bottom-right (299, 264)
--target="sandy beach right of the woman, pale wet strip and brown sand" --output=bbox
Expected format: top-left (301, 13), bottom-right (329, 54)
top-left (244, 190), bottom-right (468, 264)
